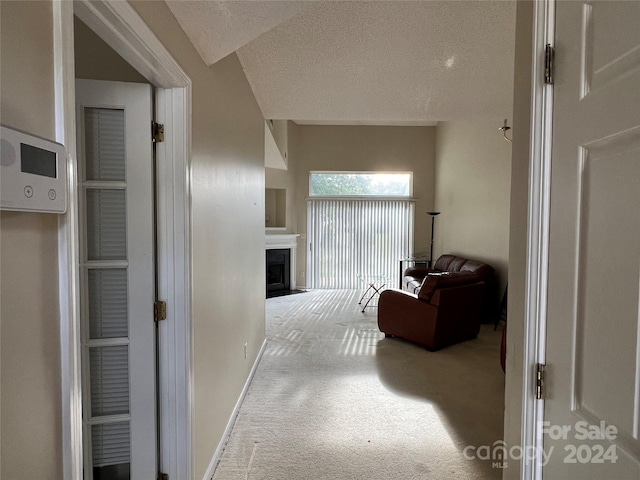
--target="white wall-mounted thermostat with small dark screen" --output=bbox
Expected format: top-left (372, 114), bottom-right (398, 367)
top-left (0, 126), bottom-right (67, 213)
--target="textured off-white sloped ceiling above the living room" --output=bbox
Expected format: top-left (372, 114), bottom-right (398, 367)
top-left (168, 0), bottom-right (515, 125)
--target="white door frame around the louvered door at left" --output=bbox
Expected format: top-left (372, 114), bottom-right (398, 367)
top-left (53, 0), bottom-right (193, 480)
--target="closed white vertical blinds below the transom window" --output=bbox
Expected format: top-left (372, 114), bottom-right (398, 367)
top-left (307, 199), bottom-right (414, 288)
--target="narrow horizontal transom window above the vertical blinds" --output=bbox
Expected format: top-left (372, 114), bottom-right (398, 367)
top-left (309, 172), bottom-right (413, 198)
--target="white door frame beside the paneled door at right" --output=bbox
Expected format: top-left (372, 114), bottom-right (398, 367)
top-left (514, 0), bottom-right (556, 480)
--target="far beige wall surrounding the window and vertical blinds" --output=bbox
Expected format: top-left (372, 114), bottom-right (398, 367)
top-left (289, 125), bottom-right (436, 285)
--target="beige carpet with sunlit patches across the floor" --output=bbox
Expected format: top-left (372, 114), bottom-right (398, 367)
top-left (213, 290), bottom-right (504, 480)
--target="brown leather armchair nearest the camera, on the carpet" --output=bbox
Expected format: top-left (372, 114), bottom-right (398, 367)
top-left (378, 271), bottom-right (486, 350)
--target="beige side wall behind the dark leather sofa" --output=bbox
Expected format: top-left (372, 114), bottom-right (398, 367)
top-left (434, 118), bottom-right (511, 292)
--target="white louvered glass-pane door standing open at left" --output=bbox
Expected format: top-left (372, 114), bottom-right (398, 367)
top-left (76, 80), bottom-right (157, 480)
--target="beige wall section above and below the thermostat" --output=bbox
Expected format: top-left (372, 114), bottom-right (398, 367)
top-left (0, 1), bottom-right (62, 480)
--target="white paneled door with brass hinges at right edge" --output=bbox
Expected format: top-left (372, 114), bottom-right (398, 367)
top-left (543, 1), bottom-right (640, 480)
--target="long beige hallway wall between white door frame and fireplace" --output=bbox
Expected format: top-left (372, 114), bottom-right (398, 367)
top-left (131, 1), bottom-right (265, 478)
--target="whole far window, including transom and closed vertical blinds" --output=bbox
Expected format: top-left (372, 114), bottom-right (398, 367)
top-left (307, 172), bottom-right (414, 288)
